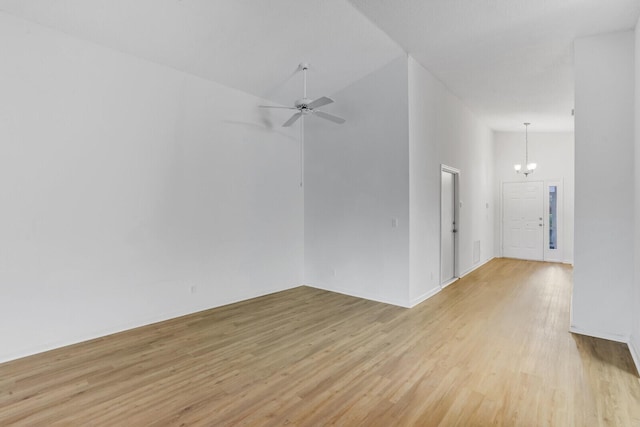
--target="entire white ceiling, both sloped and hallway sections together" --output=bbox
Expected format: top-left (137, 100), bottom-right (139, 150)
top-left (0, 0), bottom-right (640, 131)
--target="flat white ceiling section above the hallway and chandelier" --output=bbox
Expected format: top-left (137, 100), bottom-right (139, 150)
top-left (350, 0), bottom-right (640, 131)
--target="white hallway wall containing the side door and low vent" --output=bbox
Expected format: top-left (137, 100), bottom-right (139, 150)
top-left (409, 57), bottom-right (495, 305)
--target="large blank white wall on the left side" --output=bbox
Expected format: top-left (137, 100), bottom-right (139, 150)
top-left (0, 13), bottom-right (303, 361)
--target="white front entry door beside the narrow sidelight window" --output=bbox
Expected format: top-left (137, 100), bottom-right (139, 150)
top-left (502, 182), bottom-right (544, 261)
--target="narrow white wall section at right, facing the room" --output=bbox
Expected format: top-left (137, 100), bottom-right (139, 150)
top-left (571, 32), bottom-right (637, 341)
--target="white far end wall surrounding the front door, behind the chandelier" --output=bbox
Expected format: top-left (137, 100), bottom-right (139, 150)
top-left (493, 132), bottom-right (575, 263)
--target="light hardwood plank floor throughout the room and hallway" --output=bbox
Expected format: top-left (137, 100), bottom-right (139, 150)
top-left (0, 259), bottom-right (640, 426)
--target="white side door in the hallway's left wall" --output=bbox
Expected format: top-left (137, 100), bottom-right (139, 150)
top-left (440, 170), bottom-right (457, 285)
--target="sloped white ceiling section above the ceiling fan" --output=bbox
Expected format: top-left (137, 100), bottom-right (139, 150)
top-left (0, 0), bottom-right (404, 110)
